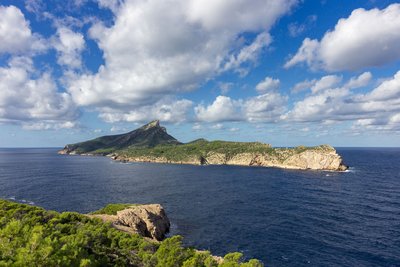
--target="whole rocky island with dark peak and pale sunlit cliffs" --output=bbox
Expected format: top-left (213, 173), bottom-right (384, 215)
top-left (58, 120), bottom-right (348, 171)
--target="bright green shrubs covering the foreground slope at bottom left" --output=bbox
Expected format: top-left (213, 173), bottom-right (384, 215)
top-left (0, 200), bottom-right (262, 267)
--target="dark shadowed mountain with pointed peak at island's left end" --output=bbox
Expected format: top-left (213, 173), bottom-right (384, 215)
top-left (59, 120), bottom-right (180, 154)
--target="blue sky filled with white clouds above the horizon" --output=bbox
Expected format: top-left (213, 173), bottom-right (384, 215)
top-left (0, 0), bottom-right (400, 147)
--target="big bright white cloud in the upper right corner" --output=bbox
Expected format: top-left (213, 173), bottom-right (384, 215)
top-left (285, 4), bottom-right (400, 71)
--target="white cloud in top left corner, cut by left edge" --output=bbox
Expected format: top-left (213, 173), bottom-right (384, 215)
top-left (0, 6), bottom-right (47, 54)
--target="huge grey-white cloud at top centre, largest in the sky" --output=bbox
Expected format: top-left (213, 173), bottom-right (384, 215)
top-left (68, 0), bottom-right (297, 121)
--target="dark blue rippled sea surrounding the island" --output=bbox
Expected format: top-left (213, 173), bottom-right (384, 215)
top-left (0, 148), bottom-right (400, 266)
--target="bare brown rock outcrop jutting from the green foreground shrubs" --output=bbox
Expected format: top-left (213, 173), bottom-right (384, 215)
top-left (88, 204), bottom-right (170, 241)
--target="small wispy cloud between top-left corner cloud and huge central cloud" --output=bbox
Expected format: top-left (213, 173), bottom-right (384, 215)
top-left (53, 27), bottom-right (85, 68)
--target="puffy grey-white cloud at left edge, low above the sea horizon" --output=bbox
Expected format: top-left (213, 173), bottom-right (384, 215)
top-left (0, 57), bottom-right (77, 129)
